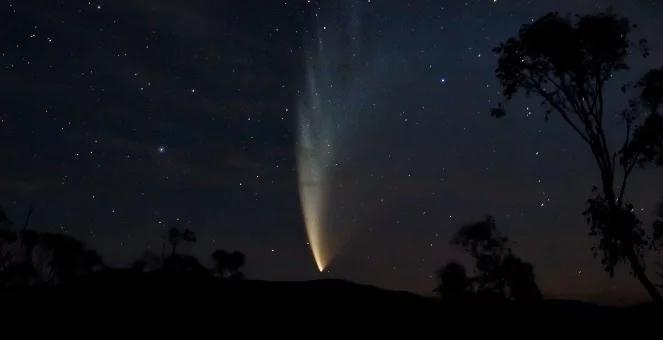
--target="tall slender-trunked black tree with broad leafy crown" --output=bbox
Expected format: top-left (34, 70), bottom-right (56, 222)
top-left (492, 12), bottom-right (663, 302)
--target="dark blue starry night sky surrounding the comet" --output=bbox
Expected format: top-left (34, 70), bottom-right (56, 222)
top-left (0, 0), bottom-right (663, 303)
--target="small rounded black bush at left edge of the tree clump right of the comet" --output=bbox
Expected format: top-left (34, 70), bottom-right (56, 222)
top-left (434, 261), bottom-right (474, 302)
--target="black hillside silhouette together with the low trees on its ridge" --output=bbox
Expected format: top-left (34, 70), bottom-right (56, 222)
top-left (0, 205), bottom-right (657, 324)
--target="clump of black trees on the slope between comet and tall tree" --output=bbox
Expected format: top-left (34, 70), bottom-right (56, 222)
top-left (436, 216), bottom-right (542, 302)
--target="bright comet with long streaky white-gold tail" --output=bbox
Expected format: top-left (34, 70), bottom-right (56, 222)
top-left (295, 1), bottom-right (370, 272)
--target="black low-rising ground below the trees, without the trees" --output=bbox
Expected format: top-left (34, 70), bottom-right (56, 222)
top-left (0, 271), bottom-right (663, 332)
